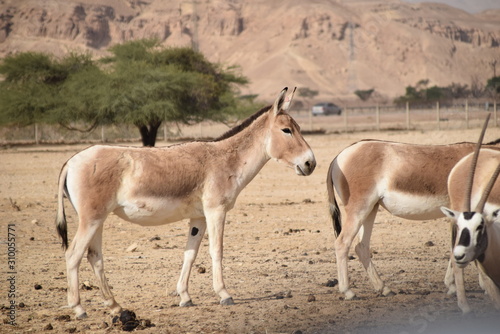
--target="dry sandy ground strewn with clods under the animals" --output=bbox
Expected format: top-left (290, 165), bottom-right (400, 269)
top-left (0, 128), bottom-right (500, 333)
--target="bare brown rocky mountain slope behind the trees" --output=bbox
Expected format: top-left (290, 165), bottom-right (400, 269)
top-left (0, 0), bottom-right (500, 102)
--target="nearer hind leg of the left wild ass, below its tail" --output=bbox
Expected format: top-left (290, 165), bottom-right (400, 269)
top-left (65, 219), bottom-right (102, 319)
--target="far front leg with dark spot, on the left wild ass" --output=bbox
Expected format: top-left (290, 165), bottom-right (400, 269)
top-left (177, 218), bottom-right (207, 306)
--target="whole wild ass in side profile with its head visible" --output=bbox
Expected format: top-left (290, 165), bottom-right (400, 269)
top-left (56, 88), bottom-right (316, 318)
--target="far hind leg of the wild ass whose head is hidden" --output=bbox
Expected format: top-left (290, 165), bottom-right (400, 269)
top-left (354, 205), bottom-right (394, 297)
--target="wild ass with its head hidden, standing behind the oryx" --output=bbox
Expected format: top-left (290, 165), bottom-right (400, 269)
top-left (326, 140), bottom-right (500, 300)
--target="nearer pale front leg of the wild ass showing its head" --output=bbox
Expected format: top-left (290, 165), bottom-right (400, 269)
top-left (206, 209), bottom-right (234, 305)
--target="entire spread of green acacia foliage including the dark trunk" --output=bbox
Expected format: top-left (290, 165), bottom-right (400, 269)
top-left (0, 40), bottom-right (257, 146)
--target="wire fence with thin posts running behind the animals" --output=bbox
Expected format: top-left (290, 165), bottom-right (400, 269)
top-left (0, 102), bottom-right (499, 146)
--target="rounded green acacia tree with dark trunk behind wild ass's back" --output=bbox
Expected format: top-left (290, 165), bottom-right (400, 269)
top-left (103, 40), bottom-right (252, 146)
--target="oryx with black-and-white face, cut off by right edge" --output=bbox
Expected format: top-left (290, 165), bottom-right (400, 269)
top-left (441, 127), bottom-right (500, 314)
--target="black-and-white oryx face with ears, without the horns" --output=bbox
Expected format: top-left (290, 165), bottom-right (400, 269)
top-left (441, 207), bottom-right (491, 268)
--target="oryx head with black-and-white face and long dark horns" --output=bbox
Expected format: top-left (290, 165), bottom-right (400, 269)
top-left (441, 115), bottom-right (500, 268)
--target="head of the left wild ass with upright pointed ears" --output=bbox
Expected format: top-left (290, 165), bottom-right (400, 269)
top-left (266, 87), bottom-right (316, 175)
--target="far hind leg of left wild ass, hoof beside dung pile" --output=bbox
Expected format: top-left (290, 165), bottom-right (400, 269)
top-left (87, 224), bottom-right (122, 314)
